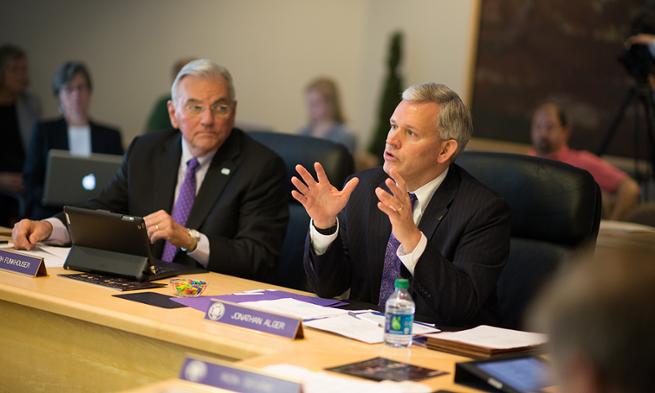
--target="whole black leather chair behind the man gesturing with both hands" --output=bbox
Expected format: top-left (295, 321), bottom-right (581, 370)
top-left (456, 151), bottom-right (601, 328)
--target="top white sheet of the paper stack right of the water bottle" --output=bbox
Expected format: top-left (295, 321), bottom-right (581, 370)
top-left (428, 325), bottom-right (547, 349)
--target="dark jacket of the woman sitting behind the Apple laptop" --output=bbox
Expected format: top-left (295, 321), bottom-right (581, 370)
top-left (23, 118), bottom-right (123, 220)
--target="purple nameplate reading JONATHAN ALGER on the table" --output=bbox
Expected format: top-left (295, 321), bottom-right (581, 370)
top-left (205, 299), bottom-right (304, 339)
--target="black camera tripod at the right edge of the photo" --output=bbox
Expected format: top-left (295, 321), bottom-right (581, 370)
top-left (596, 81), bottom-right (655, 185)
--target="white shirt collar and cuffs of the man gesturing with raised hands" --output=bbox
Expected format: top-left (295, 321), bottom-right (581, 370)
top-left (309, 168), bottom-right (448, 275)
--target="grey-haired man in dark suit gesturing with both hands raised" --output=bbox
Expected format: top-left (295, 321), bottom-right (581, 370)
top-left (292, 83), bottom-right (510, 325)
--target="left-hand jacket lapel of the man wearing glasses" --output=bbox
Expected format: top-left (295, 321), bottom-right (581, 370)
top-left (152, 131), bottom-right (182, 213)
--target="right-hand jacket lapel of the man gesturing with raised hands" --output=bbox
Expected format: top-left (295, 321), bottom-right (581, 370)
top-left (418, 164), bottom-right (460, 239)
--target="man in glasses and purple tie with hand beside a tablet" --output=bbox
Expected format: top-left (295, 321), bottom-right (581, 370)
top-left (12, 60), bottom-right (288, 280)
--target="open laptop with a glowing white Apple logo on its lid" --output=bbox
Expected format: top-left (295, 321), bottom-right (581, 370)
top-left (42, 149), bottom-right (123, 206)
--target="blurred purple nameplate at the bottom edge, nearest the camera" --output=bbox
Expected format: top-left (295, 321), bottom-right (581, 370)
top-left (180, 356), bottom-right (302, 393)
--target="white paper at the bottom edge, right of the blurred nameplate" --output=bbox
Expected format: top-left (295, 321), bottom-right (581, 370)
top-left (264, 364), bottom-right (432, 393)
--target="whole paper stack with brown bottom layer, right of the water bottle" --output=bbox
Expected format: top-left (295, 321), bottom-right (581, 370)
top-left (427, 325), bottom-right (546, 358)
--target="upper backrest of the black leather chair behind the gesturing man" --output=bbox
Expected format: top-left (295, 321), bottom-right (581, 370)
top-left (456, 151), bottom-right (601, 246)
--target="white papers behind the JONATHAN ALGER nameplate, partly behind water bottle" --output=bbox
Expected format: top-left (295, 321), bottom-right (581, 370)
top-left (304, 312), bottom-right (439, 344)
